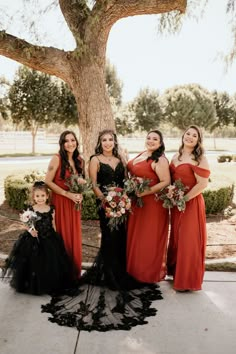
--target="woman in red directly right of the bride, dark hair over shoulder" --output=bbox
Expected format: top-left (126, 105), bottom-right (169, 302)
top-left (127, 130), bottom-right (170, 283)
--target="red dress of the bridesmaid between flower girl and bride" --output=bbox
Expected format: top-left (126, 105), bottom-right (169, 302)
top-left (52, 155), bottom-right (82, 278)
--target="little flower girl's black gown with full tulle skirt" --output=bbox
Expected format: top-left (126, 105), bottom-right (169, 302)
top-left (2, 206), bottom-right (71, 295)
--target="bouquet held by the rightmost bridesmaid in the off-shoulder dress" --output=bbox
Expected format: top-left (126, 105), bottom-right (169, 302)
top-left (157, 179), bottom-right (189, 211)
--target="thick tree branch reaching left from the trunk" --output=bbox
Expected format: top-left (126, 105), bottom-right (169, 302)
top-left (0, 31), bottom-right (70, 81)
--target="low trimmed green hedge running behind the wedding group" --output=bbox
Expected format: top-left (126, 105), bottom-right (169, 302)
top-left (4, 174), bottom-right (234, 220)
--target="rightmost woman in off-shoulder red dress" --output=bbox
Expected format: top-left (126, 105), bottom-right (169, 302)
top-left (167, 125), bottom-right (210, 291)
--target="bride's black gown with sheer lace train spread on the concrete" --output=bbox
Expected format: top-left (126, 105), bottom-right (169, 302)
top-left (42, 162), bottom-right (162, 331)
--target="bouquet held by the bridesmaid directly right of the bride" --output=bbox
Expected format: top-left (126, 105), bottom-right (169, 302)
top-left (124, 176), bottom-right (151, 207)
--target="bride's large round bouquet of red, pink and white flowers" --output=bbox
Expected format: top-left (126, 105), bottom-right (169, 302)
top-left (102, 187), bottom-right (131, 230)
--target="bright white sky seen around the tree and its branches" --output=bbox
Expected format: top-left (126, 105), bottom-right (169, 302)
top-left (0, 0), bottom-right (236, 102)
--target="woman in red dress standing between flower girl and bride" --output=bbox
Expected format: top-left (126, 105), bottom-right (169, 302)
top-left (45, 130), bottom-right (84, 279)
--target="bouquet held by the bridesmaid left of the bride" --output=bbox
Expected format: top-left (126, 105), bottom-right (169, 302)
top-left (65, 173), bottom-right (92, 210)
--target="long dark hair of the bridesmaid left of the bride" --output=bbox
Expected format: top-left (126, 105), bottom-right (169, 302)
top-left (59, 130), bottom-right (83, 179)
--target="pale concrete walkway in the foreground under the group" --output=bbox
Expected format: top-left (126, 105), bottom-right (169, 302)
top-left (0, 272), bottom-right (236, 354)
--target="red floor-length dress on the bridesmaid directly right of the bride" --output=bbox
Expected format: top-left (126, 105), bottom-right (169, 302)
top-left (127, 156), bottom-right (169, 283)
